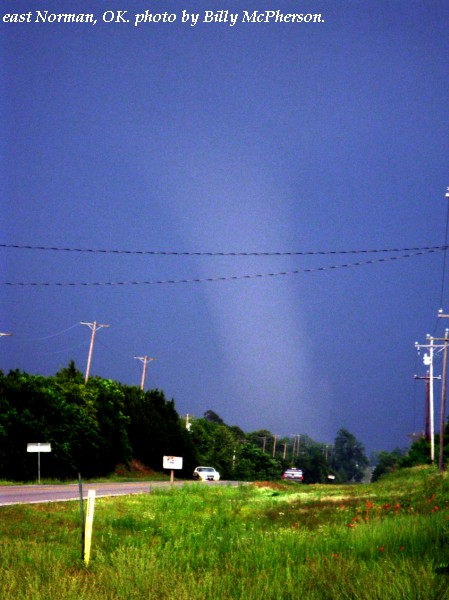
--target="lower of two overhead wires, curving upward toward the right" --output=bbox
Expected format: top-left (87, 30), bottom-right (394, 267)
top-left (0, 246), bottom-right (445, 287)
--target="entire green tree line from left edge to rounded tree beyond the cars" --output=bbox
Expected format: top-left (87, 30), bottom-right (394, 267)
top-left (0, 361), bottom-right (368, 483)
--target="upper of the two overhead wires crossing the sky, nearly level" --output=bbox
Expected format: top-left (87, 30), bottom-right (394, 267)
top-left (0, 239), bottom-right (449, 256)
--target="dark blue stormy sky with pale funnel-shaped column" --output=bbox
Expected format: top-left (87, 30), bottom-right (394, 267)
top-left (0, 0), bottom-right (449, 450)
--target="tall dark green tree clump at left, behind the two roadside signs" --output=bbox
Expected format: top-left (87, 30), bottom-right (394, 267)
top-left (0, 363), bottom-right (194, 480)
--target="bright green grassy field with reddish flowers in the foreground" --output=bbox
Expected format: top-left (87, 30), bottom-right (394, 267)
top-left (0, 468), bottom-right (449, 600)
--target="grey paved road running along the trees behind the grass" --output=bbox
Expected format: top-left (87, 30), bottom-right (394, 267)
top-left (0, 481), bottom-right (191, 506)
